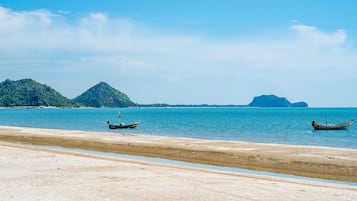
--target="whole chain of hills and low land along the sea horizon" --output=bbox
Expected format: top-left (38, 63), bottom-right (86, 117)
top-left (0, 79), bottom-right (308, 107)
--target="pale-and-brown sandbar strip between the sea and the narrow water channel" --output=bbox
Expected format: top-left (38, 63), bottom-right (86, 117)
top-left (0, 126), bottom-right (357, 182)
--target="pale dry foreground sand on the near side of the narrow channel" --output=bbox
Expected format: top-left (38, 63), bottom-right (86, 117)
top-left (0, 142), bottom-right (357, 201)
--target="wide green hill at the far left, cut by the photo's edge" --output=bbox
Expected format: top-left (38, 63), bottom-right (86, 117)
top-left (0, 79), bottom-right (76, 107)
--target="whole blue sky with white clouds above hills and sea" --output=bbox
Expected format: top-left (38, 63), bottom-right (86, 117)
top-left (0, 0), bottom-right (357, 107)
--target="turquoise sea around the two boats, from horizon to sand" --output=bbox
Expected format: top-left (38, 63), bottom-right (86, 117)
top-left (0, 108), bottom-right (357, 149)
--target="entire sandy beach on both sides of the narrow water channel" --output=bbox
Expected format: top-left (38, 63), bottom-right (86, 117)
top-left (0, 126), bottom-right (357, 200)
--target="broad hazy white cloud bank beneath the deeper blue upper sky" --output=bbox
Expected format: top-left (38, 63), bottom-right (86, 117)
top-left (0, 7), bottom-right (357, 106)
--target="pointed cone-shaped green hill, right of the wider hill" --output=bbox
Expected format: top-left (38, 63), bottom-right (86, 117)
top-left (73, 82), bottom-right (136, 107)
